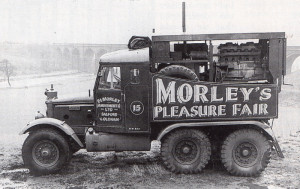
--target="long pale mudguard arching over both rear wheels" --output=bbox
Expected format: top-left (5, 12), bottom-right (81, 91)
top-left (157, 121), bottom-right (284, 158)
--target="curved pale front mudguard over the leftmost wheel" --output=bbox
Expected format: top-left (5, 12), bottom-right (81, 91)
top-left (19, 118), bottom-right (84, 147)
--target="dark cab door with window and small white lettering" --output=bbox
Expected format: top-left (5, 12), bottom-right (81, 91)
top-left (94, 66), bottom-right (125, 132)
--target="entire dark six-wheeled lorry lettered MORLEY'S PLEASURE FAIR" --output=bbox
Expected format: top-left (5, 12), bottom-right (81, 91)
top-left (21, 32), bottom-right (286, 176)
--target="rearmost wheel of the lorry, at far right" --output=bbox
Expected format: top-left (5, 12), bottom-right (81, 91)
top-left (221, 129), bottom-right (271, 176)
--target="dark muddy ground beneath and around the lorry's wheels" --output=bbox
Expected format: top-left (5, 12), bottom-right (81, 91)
top-left (0, 135), bottom-right (300, 189)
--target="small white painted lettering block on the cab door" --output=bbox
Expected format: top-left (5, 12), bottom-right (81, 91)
top-left (96, 96), bottom-right (122, 124)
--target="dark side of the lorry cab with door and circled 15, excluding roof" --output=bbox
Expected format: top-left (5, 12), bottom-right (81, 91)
top-left (94, 62), bottom-right (151, 133)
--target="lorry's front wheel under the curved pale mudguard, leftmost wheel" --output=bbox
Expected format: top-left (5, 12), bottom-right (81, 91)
top-left (22, 129), bottom-right (70, 175)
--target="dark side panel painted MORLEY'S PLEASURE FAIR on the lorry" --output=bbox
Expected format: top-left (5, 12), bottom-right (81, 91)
top-left (153, 76), bottom-right (277, 120)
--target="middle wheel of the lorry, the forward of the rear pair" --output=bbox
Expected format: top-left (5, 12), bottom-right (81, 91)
top-left (161, 129), bottom-right (211, 174)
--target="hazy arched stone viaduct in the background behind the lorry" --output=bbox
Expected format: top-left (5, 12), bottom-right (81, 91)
top-left (45, 43), bottom-right (300, 74)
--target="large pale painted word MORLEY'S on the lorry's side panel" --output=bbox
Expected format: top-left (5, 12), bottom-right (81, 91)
top-left (156, 78), bottom-right (271, 104)
